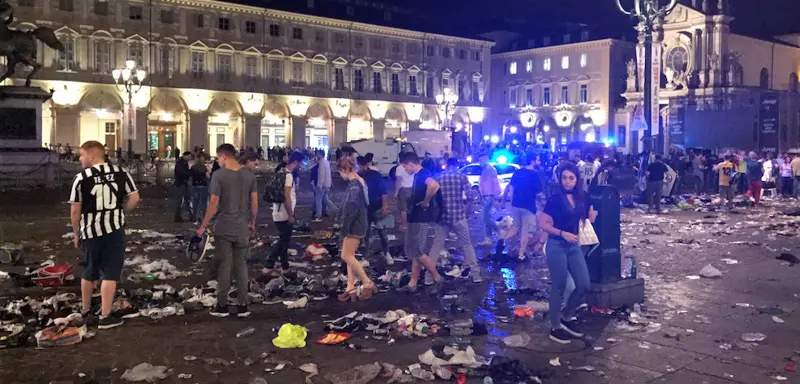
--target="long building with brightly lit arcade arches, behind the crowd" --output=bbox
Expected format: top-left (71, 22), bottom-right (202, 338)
top-left (6, 0), bottom-right (493, 156)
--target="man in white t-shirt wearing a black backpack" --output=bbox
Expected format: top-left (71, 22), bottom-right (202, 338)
top-left (264, 152), bottom-right (303, 275)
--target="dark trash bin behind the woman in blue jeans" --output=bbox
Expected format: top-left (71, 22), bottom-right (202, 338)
top-left (587, 186), bottom-right (622, 283)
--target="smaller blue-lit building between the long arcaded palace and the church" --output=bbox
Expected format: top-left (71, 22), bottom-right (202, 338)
top-left (489, 31), bottom-right (635, 151)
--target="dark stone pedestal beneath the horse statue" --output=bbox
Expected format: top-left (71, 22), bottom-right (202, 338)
top-left (0, 86), bottom-right (58, 188)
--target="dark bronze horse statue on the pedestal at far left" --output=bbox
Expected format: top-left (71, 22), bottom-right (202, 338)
top-left (0, 0), bottom-right (65, 87)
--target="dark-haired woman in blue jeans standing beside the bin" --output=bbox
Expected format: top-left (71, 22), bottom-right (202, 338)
top-left (539, 163), bottom-right (597, 344)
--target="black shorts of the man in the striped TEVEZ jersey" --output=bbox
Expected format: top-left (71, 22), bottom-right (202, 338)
top-left (81, 229), bottom-right (125, 281)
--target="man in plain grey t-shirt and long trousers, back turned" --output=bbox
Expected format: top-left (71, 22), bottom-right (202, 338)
top-left (197, 144), bottom-right (258, 317)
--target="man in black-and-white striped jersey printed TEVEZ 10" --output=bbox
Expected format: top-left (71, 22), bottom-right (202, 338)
top-left (69, 141), bottom-right (139, 329)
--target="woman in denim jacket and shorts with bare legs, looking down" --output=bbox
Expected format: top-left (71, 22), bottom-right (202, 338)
top-left (336, 157), bottom-right (375, 301)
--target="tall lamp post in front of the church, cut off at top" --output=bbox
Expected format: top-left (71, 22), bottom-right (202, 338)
top-left (616, 0), bottom-right (677, 153)
